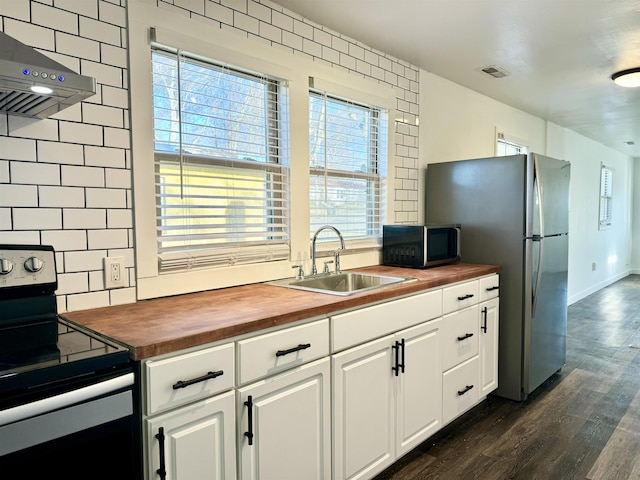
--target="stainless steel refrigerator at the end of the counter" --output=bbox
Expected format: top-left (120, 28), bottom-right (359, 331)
top-left (426, 153), bottom-right (570, 400)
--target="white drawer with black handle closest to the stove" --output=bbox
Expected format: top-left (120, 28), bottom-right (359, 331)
top-left (145, 343), bottom-right (235, 415)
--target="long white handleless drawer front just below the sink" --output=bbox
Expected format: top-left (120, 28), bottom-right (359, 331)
top-left (331, 289), bottom-right (442, 352)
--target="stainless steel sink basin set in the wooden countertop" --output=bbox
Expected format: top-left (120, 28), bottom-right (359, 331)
top-left (268, 272), bottom-right (416, 295)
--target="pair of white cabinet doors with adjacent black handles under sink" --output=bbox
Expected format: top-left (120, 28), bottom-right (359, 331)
top-left (332, 319), bottom-right (442, 480)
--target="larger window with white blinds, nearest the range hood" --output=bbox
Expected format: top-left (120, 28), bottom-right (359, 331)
top-left (152, 49), bottom-right (289, 272)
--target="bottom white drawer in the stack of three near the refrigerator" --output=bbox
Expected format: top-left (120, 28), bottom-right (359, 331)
top-left (442, 356), bottom-right (480, 424)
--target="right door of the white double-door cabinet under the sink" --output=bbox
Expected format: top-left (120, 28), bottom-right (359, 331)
top-left (396, 319), bottom-right (442, 456)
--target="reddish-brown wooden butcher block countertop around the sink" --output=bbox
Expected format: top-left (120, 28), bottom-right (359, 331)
top-left (60, 263), bottom-right (500, 360)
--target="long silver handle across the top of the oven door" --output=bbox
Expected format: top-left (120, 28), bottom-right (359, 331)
top-left (0, 373), bottom-right (133, 426)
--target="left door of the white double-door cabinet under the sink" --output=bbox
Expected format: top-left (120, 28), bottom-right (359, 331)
top-left (332, 335), bottom-right (395, 480)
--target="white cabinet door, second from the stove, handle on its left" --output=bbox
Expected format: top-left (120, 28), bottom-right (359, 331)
top-left (237, 358), bottom-right (331, 480)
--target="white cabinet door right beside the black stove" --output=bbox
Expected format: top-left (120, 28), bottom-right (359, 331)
top-left (146, 391), bottom-right (236, 480)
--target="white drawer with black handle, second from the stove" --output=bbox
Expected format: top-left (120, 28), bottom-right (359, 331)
top-left (238, 319), bottom-right (329, 384)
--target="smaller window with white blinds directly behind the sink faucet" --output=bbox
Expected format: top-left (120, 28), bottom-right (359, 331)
top-left (309, 91), bottom-right (388, 244)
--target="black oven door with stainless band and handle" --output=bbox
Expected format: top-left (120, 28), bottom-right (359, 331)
top-left (0, 372), bottom-right (137, 480)
